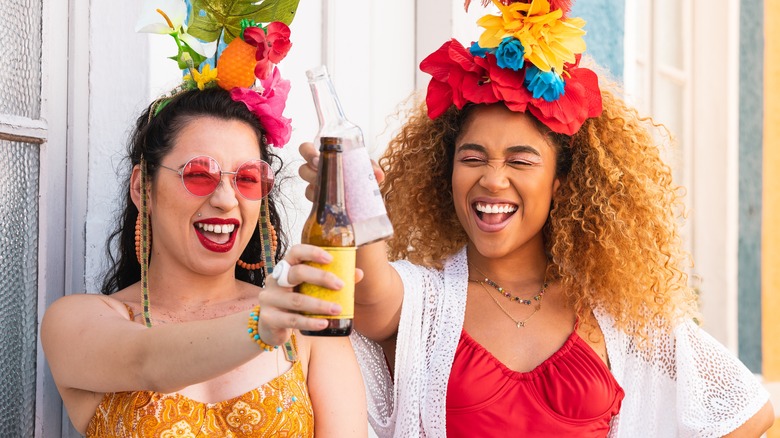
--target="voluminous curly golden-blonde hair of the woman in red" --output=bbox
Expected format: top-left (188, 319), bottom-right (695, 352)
top-left (380, 86), bottom-right (697, 340)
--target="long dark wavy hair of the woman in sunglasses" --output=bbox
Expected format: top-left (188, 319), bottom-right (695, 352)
top-left (101, 88), bottom-right (287, 295)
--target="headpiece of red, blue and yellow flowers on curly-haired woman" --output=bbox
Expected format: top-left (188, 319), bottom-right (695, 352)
top-left (420, 0), bottom-right (602, 135)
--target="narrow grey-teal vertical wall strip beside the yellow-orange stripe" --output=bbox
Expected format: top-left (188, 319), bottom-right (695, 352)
top-left (737, 0), bottom-right (764, 373)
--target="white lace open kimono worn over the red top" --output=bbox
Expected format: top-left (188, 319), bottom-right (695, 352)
top-left (352, 249), bottom-right (769, 438)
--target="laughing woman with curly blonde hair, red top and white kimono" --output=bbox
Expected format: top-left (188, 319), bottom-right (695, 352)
top-left (300, 1), bottom-right (773, 437)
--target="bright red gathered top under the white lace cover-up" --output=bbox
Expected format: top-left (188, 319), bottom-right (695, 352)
top-left (447, 330), bottom-right (623, 438)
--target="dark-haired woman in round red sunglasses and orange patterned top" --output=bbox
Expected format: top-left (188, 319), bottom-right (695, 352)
top-left (41, 5), bottom-right (368, 437)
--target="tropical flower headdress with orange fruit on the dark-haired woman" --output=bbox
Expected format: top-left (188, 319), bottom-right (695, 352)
top-left (136, 0), bottom-right (299, 147)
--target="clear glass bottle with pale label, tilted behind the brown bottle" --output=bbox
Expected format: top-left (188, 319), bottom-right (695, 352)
top-left (306, 66), bottom-right (393, 246)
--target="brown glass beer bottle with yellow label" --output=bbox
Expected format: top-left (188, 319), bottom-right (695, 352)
top-left (297, 137), bottom-right (357, 336)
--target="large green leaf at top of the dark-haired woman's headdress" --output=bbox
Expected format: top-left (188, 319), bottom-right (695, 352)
top-left (187, 0), bottom-right (300, 44)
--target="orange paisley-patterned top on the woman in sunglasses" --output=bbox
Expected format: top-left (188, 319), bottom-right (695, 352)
top-left (87, 361), bottom-right (314, 438)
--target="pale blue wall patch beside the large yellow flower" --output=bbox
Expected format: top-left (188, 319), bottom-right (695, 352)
top-left (571, 0), bottom-right (626, 82)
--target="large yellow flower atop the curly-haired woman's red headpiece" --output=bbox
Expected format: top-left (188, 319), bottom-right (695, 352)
top-left (477, 0), bottom-right (585, 74)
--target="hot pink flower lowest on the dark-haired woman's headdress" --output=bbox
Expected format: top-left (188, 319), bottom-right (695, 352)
top-left (230, 67), bottom-right (292, 148)
